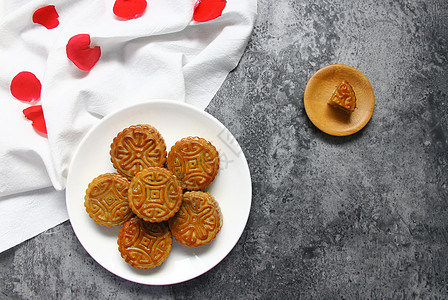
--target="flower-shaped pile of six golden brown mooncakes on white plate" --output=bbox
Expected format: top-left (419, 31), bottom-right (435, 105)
top-left (84, 124), bottom-right (222, 269)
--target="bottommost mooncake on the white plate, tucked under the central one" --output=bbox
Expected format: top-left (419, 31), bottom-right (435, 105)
top-left (117, 217), bottom-right (173, 269)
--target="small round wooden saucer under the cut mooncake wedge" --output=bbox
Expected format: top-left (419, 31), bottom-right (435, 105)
top-left (303, 64), bottom-right (375, 136)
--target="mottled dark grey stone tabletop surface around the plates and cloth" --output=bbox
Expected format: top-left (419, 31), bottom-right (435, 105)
top-left (0, 0), bottom-right (448, 299)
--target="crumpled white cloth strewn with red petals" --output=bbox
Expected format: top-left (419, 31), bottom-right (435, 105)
top-left (0, 0), bottom-right (257, 252)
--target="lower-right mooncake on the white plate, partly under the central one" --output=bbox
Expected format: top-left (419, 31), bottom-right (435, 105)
top-left (168, 191), bottom-right (223, 247)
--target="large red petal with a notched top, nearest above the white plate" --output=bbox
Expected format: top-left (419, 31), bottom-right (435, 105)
top-left (66, 34), bottom-right (101, 71)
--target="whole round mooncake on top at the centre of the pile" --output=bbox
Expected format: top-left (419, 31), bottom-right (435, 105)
top-left (128, 167), bottom-right (182, 222)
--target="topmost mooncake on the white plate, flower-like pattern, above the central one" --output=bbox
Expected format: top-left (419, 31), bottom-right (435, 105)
top-left (110, 124), bottom-right (167, 179)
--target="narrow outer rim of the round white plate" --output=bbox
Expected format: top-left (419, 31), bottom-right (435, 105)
top-left (65, 99), bottom-right (253, 286)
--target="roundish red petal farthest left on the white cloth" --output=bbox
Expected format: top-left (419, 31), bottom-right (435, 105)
top-left (10, 71), bottom-right (42, 102)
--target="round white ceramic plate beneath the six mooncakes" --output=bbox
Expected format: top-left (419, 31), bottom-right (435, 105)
top-left (66, 101), bottom-right (252, 285)
